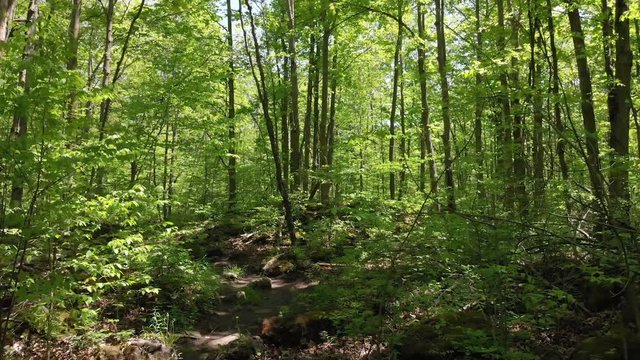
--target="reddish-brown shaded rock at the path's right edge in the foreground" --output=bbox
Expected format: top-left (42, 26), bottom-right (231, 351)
top-left (260, 312), bottom-right (335, 347)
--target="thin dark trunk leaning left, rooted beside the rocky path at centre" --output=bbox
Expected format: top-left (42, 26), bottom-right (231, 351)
top-left (243, 0), bottom-right (297, 245)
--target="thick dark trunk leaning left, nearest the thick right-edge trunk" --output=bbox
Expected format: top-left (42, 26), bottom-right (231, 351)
top-left (568, 4), bottom-right (606, 211)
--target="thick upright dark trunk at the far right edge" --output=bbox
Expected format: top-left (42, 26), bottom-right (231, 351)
top-left (609, 0), bottom-right (632, 226)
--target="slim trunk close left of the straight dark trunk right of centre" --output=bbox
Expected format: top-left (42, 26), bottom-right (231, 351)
top-left (417, 0), bottom-right (438, 200)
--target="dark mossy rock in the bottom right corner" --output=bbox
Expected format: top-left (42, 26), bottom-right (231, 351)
top-left (571, 329), bottom-right (640, 360)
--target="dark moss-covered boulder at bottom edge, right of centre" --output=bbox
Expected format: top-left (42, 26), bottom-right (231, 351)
top-left (397, 310), bottom-right (498, 360)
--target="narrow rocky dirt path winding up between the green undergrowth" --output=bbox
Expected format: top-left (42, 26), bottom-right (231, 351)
top-left (175, 229), bottom-right (318, 360)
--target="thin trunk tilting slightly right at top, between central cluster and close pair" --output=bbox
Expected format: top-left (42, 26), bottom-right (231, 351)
top-left (389, 0), bottom-right (404, 200)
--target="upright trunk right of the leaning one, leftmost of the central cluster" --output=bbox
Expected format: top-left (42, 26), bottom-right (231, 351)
top-left (287, 0), bottom-right (302, 191)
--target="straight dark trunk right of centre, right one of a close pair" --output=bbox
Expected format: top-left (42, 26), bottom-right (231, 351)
top-left (435, 0), bottom-right (456, 212)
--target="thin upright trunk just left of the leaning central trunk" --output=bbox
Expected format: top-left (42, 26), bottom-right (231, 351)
top-left (227, 0), bottom-right (238, 212)
